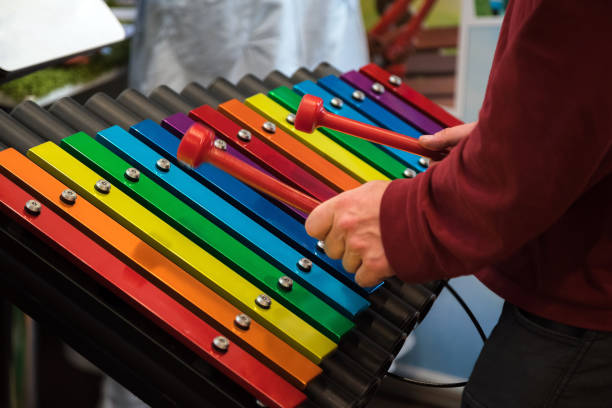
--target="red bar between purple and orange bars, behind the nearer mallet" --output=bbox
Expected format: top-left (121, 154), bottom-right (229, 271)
top-left (189, 105), bottom-right (336, 200)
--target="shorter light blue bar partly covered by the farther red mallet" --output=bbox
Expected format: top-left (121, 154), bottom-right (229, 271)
top-left (293, 77), bottom-right (427, 172)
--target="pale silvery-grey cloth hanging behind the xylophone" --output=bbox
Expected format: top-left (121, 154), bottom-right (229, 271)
top-left (130, 0), bottom-right (368, 93)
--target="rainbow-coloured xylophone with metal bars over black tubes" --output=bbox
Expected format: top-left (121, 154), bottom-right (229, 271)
top-left (0, 63), bottom-right (459, 407)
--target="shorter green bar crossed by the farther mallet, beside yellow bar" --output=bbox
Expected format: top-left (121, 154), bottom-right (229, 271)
top-left (268, 86), bottom-right (406, 178)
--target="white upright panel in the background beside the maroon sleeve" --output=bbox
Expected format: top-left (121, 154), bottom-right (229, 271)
top-left (455, 0), bottom-right (503, 122)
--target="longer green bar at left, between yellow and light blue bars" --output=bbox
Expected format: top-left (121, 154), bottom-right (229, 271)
top-left (61, 132), bottom-right (353, 342)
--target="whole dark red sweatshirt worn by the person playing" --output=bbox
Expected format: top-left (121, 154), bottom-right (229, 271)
top-left (381, 0), bottom-right (612, 330)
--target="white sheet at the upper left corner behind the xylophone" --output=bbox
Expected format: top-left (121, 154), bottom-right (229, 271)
top-left (0, 0), bottom-right (125, 77)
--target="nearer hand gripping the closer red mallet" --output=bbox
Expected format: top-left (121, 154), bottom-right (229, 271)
top-left (306, 181), bottom-right (395, 286)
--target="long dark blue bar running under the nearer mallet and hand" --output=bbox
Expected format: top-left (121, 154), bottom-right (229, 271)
top-left (137, 120), bottom-right (376, 293)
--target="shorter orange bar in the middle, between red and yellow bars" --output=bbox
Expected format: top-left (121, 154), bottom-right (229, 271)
top-left (217, 99), bottom-right (361, 192)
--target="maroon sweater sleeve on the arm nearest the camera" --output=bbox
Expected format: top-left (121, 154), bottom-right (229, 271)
top-left (381, 0), bottom-right (612, 282)
